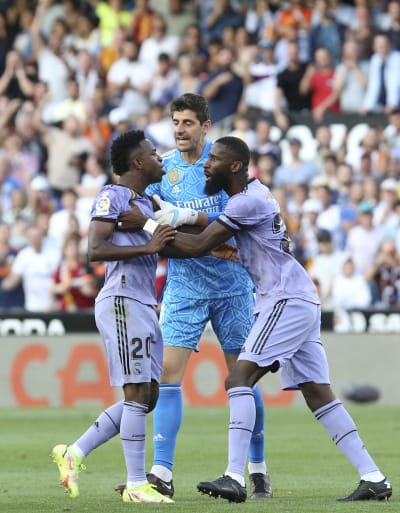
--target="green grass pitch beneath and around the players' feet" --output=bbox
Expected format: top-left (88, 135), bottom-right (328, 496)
top-left (0, 404), bottom-right (400, 513)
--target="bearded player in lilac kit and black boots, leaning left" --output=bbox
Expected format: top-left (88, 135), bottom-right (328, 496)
top-left (129, 137), bottom-right (392, 502)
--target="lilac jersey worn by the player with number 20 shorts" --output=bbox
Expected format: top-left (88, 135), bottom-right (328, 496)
top-left (91, 185), bottom-right (157, 305)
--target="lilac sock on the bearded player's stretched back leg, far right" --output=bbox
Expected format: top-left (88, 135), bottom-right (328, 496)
top-left (313, 399), bottom-right (378, 476)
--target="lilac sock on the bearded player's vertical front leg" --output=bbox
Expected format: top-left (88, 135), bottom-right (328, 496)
top-left (226, 387), bottom-right (256, 476)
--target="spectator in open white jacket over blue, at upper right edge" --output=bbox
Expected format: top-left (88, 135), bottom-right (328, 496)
top-left (361, 33), bottom-right (400, 113)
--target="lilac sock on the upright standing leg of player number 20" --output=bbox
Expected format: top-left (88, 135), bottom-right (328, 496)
top-left (120, 401), bottom-right (149, 481)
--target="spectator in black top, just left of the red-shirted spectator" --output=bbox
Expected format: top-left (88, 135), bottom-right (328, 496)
top-left (274, 42), bottom-right (311, 131)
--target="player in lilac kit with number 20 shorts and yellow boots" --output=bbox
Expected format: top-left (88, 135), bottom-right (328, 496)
top-left (52, 130), bottom-right (176, 503)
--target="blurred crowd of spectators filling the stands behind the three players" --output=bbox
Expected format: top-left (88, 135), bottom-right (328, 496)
top-left (0, 0), bottom-right (400, 312)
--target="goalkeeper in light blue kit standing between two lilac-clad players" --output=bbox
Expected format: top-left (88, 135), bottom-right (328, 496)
top-left (146, 93), bottom-right (272, 499)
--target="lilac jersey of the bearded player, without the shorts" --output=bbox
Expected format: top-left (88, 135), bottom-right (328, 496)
top-left (218, 180), bottom-right (320, 312)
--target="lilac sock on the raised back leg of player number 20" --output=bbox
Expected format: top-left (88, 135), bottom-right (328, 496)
top-left (74, 401), bottom-right (123, 456)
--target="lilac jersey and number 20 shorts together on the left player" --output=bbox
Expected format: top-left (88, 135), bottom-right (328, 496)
top-left (92, 185), bottom-right (163, 386)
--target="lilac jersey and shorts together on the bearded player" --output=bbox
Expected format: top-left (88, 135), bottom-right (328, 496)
top-left (218, 180), bottom-right (329, 389)
